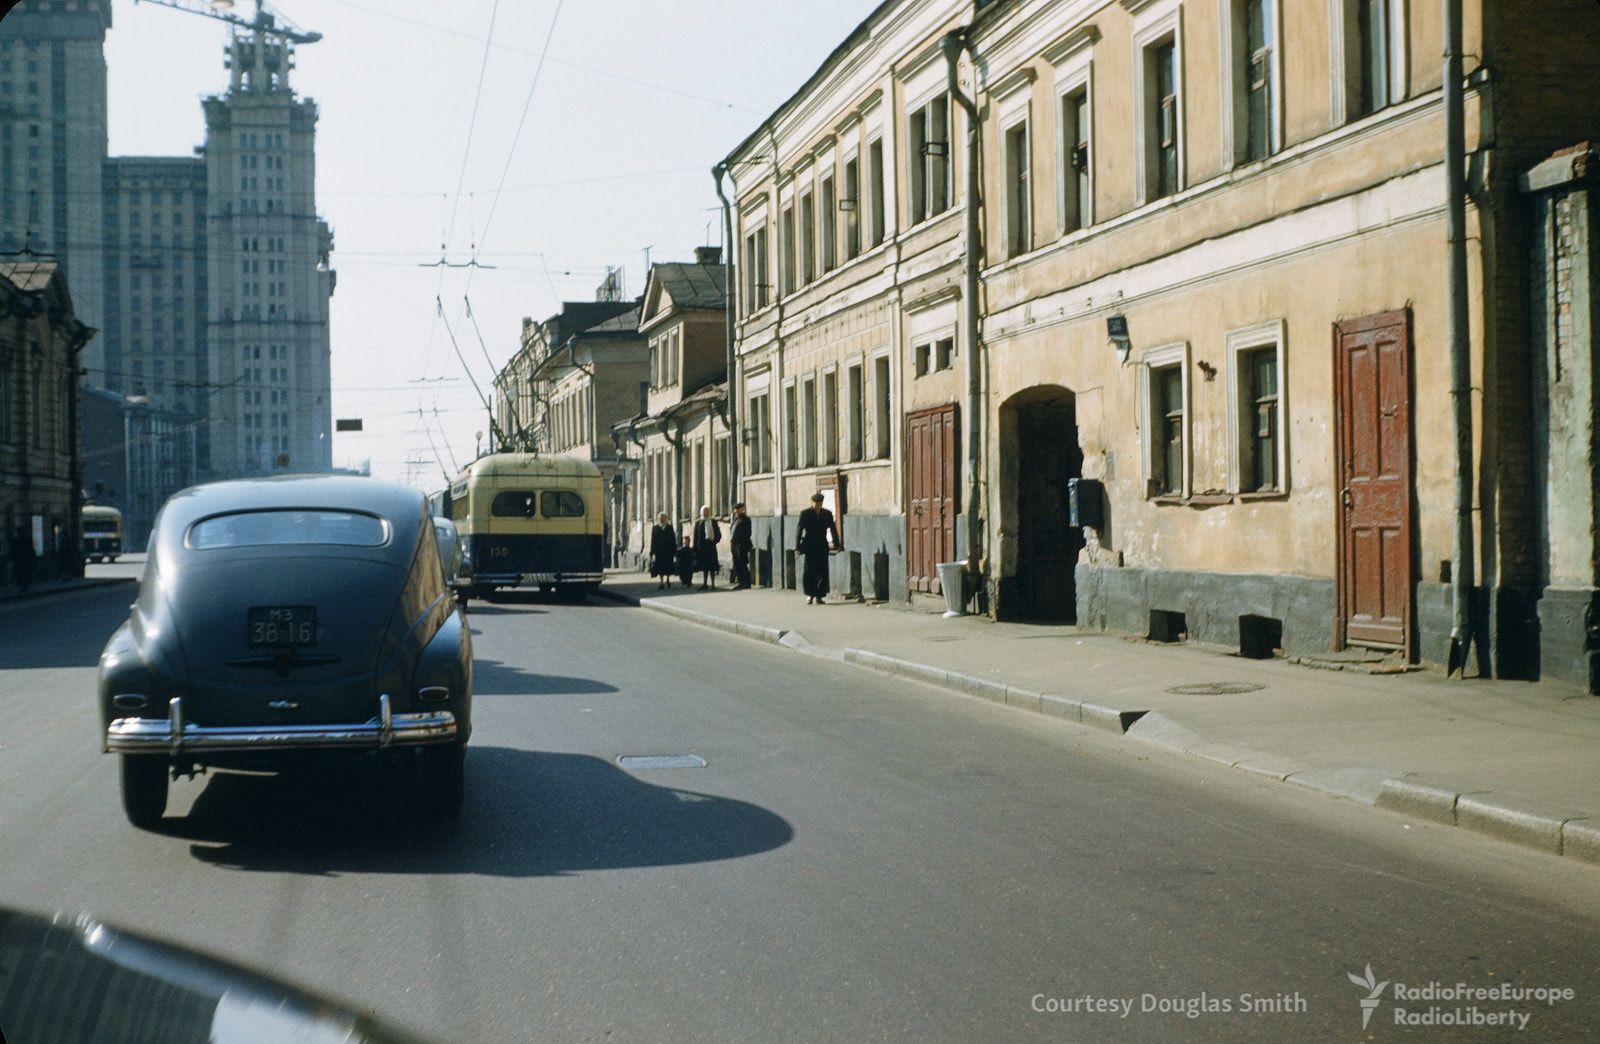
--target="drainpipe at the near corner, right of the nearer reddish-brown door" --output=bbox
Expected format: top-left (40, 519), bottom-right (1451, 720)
top-left (1443, 0), bottom-right (1474, 677)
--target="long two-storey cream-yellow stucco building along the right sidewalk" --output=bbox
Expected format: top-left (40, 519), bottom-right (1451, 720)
top-left (725, 0), bottom-right (1600, 684)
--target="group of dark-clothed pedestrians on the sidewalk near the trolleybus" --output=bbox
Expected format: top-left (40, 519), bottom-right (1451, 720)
top-left (650, 493), bottom-right (843, 605)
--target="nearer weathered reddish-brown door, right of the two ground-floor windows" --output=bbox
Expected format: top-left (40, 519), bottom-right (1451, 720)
top-left (1334, 312), bottom-right (1414, 650)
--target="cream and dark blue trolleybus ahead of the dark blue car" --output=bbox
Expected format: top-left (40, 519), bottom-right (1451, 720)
top-left (450, 453), bottom-right (605, 597)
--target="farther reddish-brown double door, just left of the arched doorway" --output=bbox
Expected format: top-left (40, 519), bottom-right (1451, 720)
top-left (906, 404), bottom-right (958, 594)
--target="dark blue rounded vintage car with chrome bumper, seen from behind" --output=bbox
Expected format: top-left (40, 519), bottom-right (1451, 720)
top-left (99, 476), bottom-right (472, 826)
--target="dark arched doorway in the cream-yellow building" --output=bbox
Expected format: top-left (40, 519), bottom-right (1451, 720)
top-left (997, 386), bottom-right (1083, 623)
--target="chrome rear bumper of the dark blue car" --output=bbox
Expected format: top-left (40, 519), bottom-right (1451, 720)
top-left (104, 697), bottom-right (456, 757)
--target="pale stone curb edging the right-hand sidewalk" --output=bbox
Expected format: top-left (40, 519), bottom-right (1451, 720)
top-left (598, 588), bottom-right (1600, 865)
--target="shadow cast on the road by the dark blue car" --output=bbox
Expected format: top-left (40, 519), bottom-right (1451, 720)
top-left (172, 746), bottom-right (794, 877)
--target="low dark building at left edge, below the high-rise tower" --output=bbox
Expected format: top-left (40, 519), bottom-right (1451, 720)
top-left (0, 256), bottom-right (94, 580)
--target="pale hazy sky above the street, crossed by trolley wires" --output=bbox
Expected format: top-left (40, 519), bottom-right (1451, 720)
top-left (106, 0), bottom-right (877, 488)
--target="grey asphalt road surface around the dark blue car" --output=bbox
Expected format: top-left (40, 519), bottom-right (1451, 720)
top-left (0, 582), bottom-right (1600, 1041)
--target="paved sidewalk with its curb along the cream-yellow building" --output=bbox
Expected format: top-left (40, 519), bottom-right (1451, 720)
top-left (600, 573), bottom-right (1600, 863)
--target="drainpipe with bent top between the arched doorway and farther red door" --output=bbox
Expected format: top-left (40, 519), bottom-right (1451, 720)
top-left (939, 26), bottom-right (986, 608)
